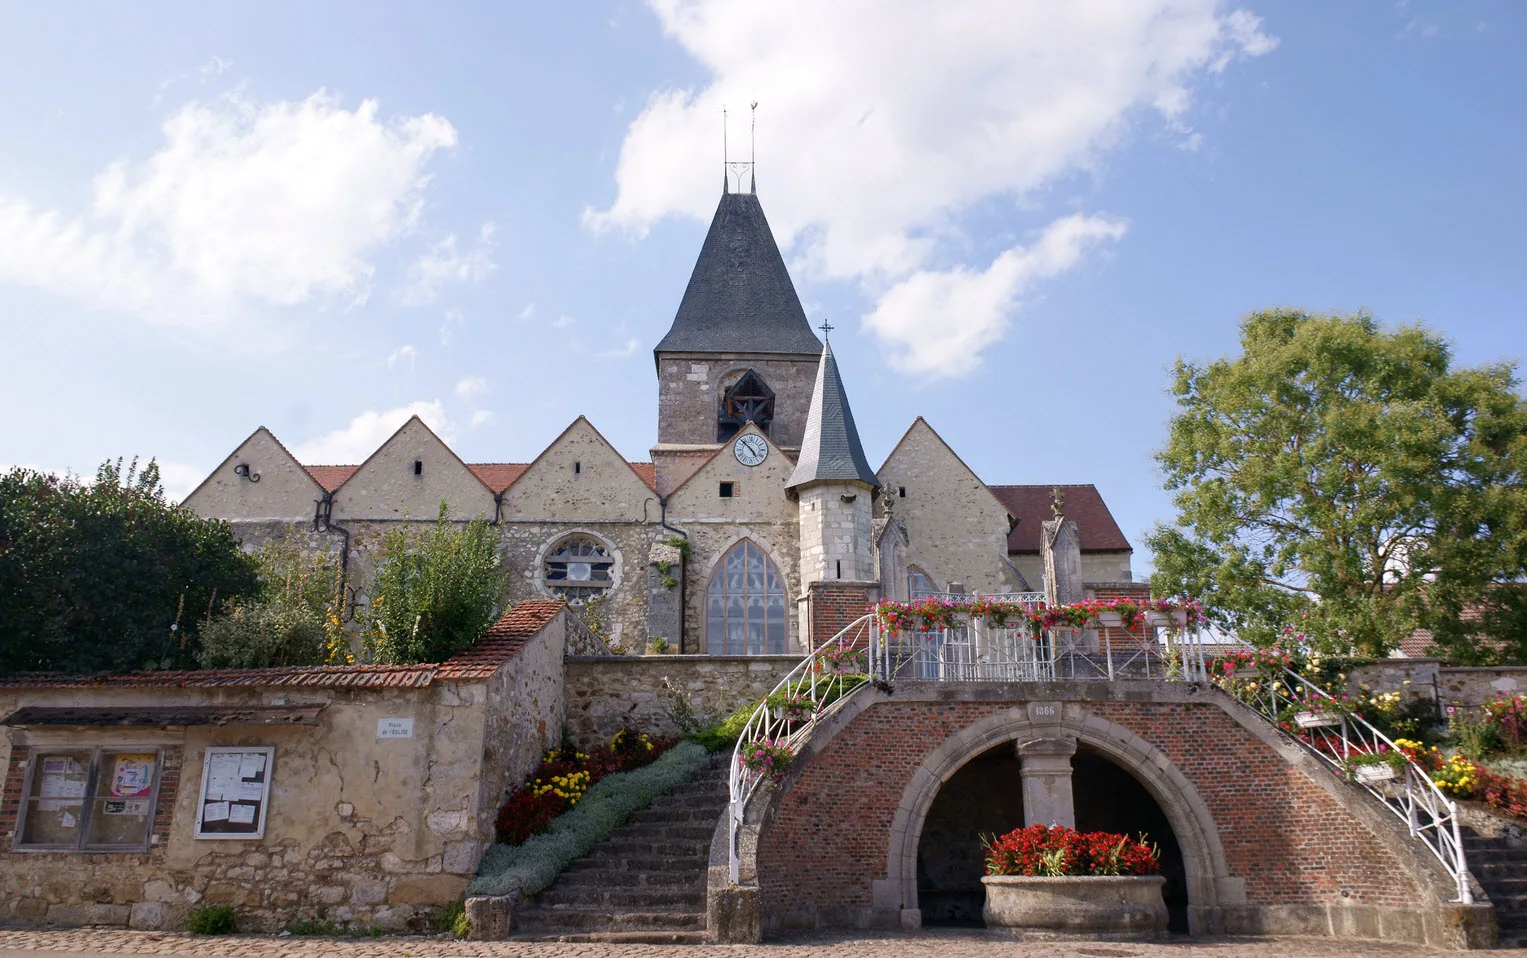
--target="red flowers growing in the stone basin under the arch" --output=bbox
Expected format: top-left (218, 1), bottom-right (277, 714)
top-left (982, 825), bottom-right (1161, 877)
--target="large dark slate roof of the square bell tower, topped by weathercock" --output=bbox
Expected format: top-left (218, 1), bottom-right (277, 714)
top-left (654, 193), bottom-right (822, 356)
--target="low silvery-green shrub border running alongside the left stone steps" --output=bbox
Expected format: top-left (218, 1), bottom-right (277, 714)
top-left (467, 743), bottom-right (710, 895)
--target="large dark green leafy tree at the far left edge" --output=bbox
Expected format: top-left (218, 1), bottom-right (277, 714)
top-left (0, 460), bottom-right (257, 672)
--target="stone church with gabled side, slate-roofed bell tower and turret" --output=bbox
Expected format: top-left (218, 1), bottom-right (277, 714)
top-left (185, 193), bottom-right (1139, 655)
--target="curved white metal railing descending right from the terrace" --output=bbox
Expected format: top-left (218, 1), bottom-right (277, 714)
top-left (1226, 668), bottom-right (1474, 905)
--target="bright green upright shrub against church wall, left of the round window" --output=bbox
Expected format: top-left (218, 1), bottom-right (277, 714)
top-left (363, 503), bottom-right (508, 663)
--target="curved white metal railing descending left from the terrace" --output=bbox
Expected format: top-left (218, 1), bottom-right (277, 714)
top-left (727, 613), bottom-right (878, 885)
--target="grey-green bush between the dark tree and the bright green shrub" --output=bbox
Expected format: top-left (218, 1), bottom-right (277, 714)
top-left (202, 532), bottom-right (354, 669)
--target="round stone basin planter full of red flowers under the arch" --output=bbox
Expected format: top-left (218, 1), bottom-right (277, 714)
top-left (980, 825), bottom-right (1167, 938)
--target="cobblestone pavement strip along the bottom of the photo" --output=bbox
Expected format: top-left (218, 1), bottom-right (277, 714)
top-left (0, 929), bottom-right (1478, 958)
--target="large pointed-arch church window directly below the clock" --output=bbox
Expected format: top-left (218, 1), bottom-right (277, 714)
top-left (705, 539), bottom-right (788, 655)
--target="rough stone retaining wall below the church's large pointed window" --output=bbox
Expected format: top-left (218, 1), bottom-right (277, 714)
top-left (567, 655), bottom-right (800, 747)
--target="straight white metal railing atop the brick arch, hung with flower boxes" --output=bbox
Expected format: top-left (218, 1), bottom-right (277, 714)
top-left (870, 611), bottom-right (1208, 681)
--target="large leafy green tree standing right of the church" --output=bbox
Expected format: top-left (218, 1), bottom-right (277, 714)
top-left (1147, 310), bottom-right (1527, 657)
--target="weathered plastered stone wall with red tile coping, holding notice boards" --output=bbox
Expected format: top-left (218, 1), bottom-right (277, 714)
top-left (0, 602), bottom-right (565, 930)
